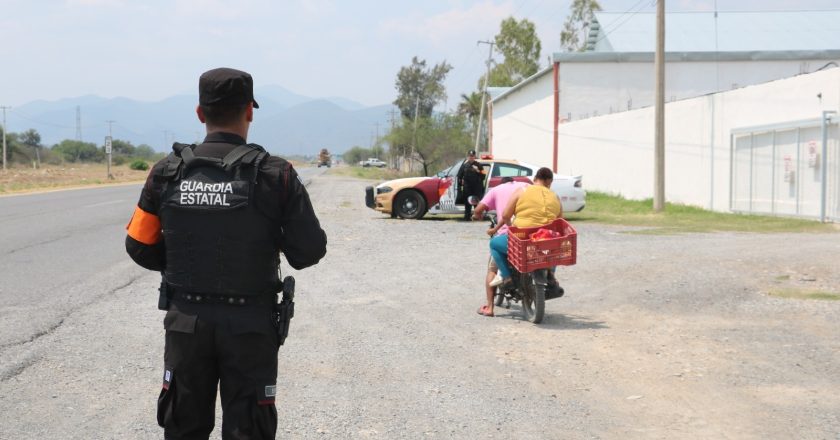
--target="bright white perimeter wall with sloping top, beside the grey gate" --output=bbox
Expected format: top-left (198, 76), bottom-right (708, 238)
top-left (556, 69), bottom-right (840, 217)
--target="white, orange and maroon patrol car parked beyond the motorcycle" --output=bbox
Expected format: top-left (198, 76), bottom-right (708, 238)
top-left (365, 155), bottom-right (586, 219)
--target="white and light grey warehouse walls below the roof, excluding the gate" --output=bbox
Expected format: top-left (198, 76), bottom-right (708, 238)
top-left (491, 62), bottom-right (840, 217)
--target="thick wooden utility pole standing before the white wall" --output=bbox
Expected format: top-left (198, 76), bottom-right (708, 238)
top-left (653, 0), bottom-right (665, 212)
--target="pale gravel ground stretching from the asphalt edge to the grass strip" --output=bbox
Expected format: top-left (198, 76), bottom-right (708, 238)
top-left (0, 176), bottom-right (840, 439)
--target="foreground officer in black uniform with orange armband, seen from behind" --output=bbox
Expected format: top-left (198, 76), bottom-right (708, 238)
top-left (126, 68), bottom-right (327, 440)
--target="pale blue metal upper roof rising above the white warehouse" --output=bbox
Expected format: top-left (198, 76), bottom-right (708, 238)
top-left (586, 9), bottom-right (840, 52)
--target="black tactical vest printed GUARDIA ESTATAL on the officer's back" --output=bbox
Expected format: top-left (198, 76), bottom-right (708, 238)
top-left (154, 144), bottom-right (280, 296)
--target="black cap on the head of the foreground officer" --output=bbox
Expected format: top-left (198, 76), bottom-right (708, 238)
top-left (198, 67), bottom-right (260, 108)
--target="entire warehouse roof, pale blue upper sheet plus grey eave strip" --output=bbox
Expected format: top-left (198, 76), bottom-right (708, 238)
top-left (488, 9), bottom-right (840, 103)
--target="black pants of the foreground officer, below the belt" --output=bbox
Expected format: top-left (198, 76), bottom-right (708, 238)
top-left (157, 302), bottom-right (279, 440)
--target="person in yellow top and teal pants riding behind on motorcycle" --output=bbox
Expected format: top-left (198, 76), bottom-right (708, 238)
top-left (487, 167), bottom-right (563, 287)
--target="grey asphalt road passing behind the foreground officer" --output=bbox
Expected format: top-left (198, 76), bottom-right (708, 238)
top-left (0, 168), bottom-right (323, 380)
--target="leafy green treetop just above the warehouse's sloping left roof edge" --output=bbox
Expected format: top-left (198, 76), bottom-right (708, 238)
top-left (486, 17), bottom-right (542, 87)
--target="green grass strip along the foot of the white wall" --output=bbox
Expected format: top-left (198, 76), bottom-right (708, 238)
top-left (567, 191), bottom-right (838, 234)
